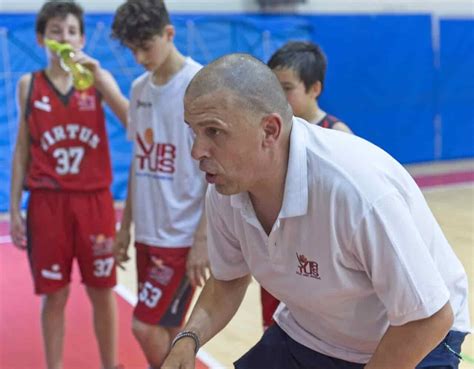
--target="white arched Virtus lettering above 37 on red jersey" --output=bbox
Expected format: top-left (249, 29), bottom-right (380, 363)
top-left (41, 123), bottom-right (100, 151)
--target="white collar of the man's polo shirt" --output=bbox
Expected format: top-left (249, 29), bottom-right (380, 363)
top-left (230, 117), bottom-right (308, 218)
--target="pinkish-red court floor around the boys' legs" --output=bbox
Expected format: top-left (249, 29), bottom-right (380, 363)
top-left (0, 222), bottom-right (207, 369)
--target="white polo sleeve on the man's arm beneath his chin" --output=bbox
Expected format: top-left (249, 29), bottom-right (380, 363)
top-left (206, 186), bottom-right (250, 281)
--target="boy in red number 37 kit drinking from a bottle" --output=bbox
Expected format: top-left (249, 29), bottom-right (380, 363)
top-left (10, 1), bottom-right (128, 369)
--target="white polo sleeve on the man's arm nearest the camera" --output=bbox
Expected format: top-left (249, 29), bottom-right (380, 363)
top-left (351, 193), bottom-right (449, 326)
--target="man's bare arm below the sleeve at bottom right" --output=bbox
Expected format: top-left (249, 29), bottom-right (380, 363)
top-left (365, 302), bottom-right (453, 369)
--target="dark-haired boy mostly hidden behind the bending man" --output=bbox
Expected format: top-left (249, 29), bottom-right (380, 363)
top-left (260, 41), bottom-right (352, 329)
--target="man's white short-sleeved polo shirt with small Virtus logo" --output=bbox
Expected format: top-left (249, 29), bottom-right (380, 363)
top-left (207, 118), bottom-right (470, 363)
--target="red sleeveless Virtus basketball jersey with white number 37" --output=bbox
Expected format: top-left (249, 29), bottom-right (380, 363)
top-left (25, 71), bottom-right (112, 191)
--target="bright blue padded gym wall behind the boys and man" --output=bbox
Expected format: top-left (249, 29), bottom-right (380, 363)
top-left (0, 13), bottom-right (474, 211)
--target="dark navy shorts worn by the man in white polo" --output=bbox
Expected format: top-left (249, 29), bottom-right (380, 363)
top-left (234, 324), bottom-right (466, 369)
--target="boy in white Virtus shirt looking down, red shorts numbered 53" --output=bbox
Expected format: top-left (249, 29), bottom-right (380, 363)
top-left (112, 0), bottom-right (208, 368)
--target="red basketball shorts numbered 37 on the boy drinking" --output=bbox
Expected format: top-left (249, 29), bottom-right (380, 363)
top-left (27, 190), bottom-right (116, 294)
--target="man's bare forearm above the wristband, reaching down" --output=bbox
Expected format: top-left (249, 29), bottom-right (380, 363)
top-left (184, 275), bottom-right (250, 344)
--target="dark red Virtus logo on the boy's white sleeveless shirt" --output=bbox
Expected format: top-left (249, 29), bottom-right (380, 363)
top-left (136, 128), bottom-right (176, 174)
